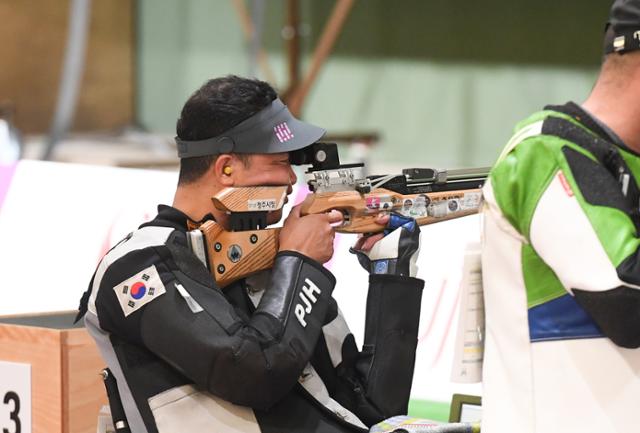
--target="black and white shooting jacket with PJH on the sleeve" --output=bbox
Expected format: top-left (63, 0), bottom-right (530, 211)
top-left (81, 205), bottom-right (423, 433)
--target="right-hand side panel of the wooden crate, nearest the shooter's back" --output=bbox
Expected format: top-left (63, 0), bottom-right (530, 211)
top-left (62, 329), bottom-right (107, 433)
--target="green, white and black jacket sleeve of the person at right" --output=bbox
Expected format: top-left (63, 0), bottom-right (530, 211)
top-left (492, 135), bottom-right (640, 348)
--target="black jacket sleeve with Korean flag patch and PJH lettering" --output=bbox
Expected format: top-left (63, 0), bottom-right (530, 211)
top-left (96, 232), bottom-right (335, 409)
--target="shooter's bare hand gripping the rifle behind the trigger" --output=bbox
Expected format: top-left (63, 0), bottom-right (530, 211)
top-left (279, 205), bottom-right (342, 263)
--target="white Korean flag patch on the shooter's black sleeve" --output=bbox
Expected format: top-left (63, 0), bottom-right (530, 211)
top-left (113, 265), bottom-right (166, 317)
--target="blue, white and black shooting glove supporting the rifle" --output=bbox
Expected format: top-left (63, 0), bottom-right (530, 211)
top-left (349, 213), bottom-right (420, 277)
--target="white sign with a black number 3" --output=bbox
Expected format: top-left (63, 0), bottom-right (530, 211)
top-left (0, 361), bottom-right (31, 433)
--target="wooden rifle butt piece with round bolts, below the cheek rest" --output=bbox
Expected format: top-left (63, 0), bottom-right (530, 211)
top-left (200, 221), bottom-right (280, 288)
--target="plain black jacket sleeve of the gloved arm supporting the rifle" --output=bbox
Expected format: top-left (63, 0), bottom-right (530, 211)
top-left (313, 275), bottom-right (424, 425)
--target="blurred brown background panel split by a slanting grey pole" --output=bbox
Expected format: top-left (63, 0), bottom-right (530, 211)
top-left (0, 0), bottom-right (134, 132)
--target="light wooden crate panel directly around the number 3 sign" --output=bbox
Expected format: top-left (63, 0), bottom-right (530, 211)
top-left (0, 325), bottom-right (62, 433)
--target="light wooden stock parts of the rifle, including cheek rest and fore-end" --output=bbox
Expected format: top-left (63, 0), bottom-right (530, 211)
top-left (199, 176), bottom-right (481, 287)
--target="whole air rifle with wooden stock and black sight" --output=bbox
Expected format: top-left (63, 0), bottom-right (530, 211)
top-left (189, 143), bottom-right (489, 287)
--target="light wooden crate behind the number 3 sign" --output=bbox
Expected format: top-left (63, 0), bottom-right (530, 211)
top-left (0, 312), bottom-right (107, 433)
